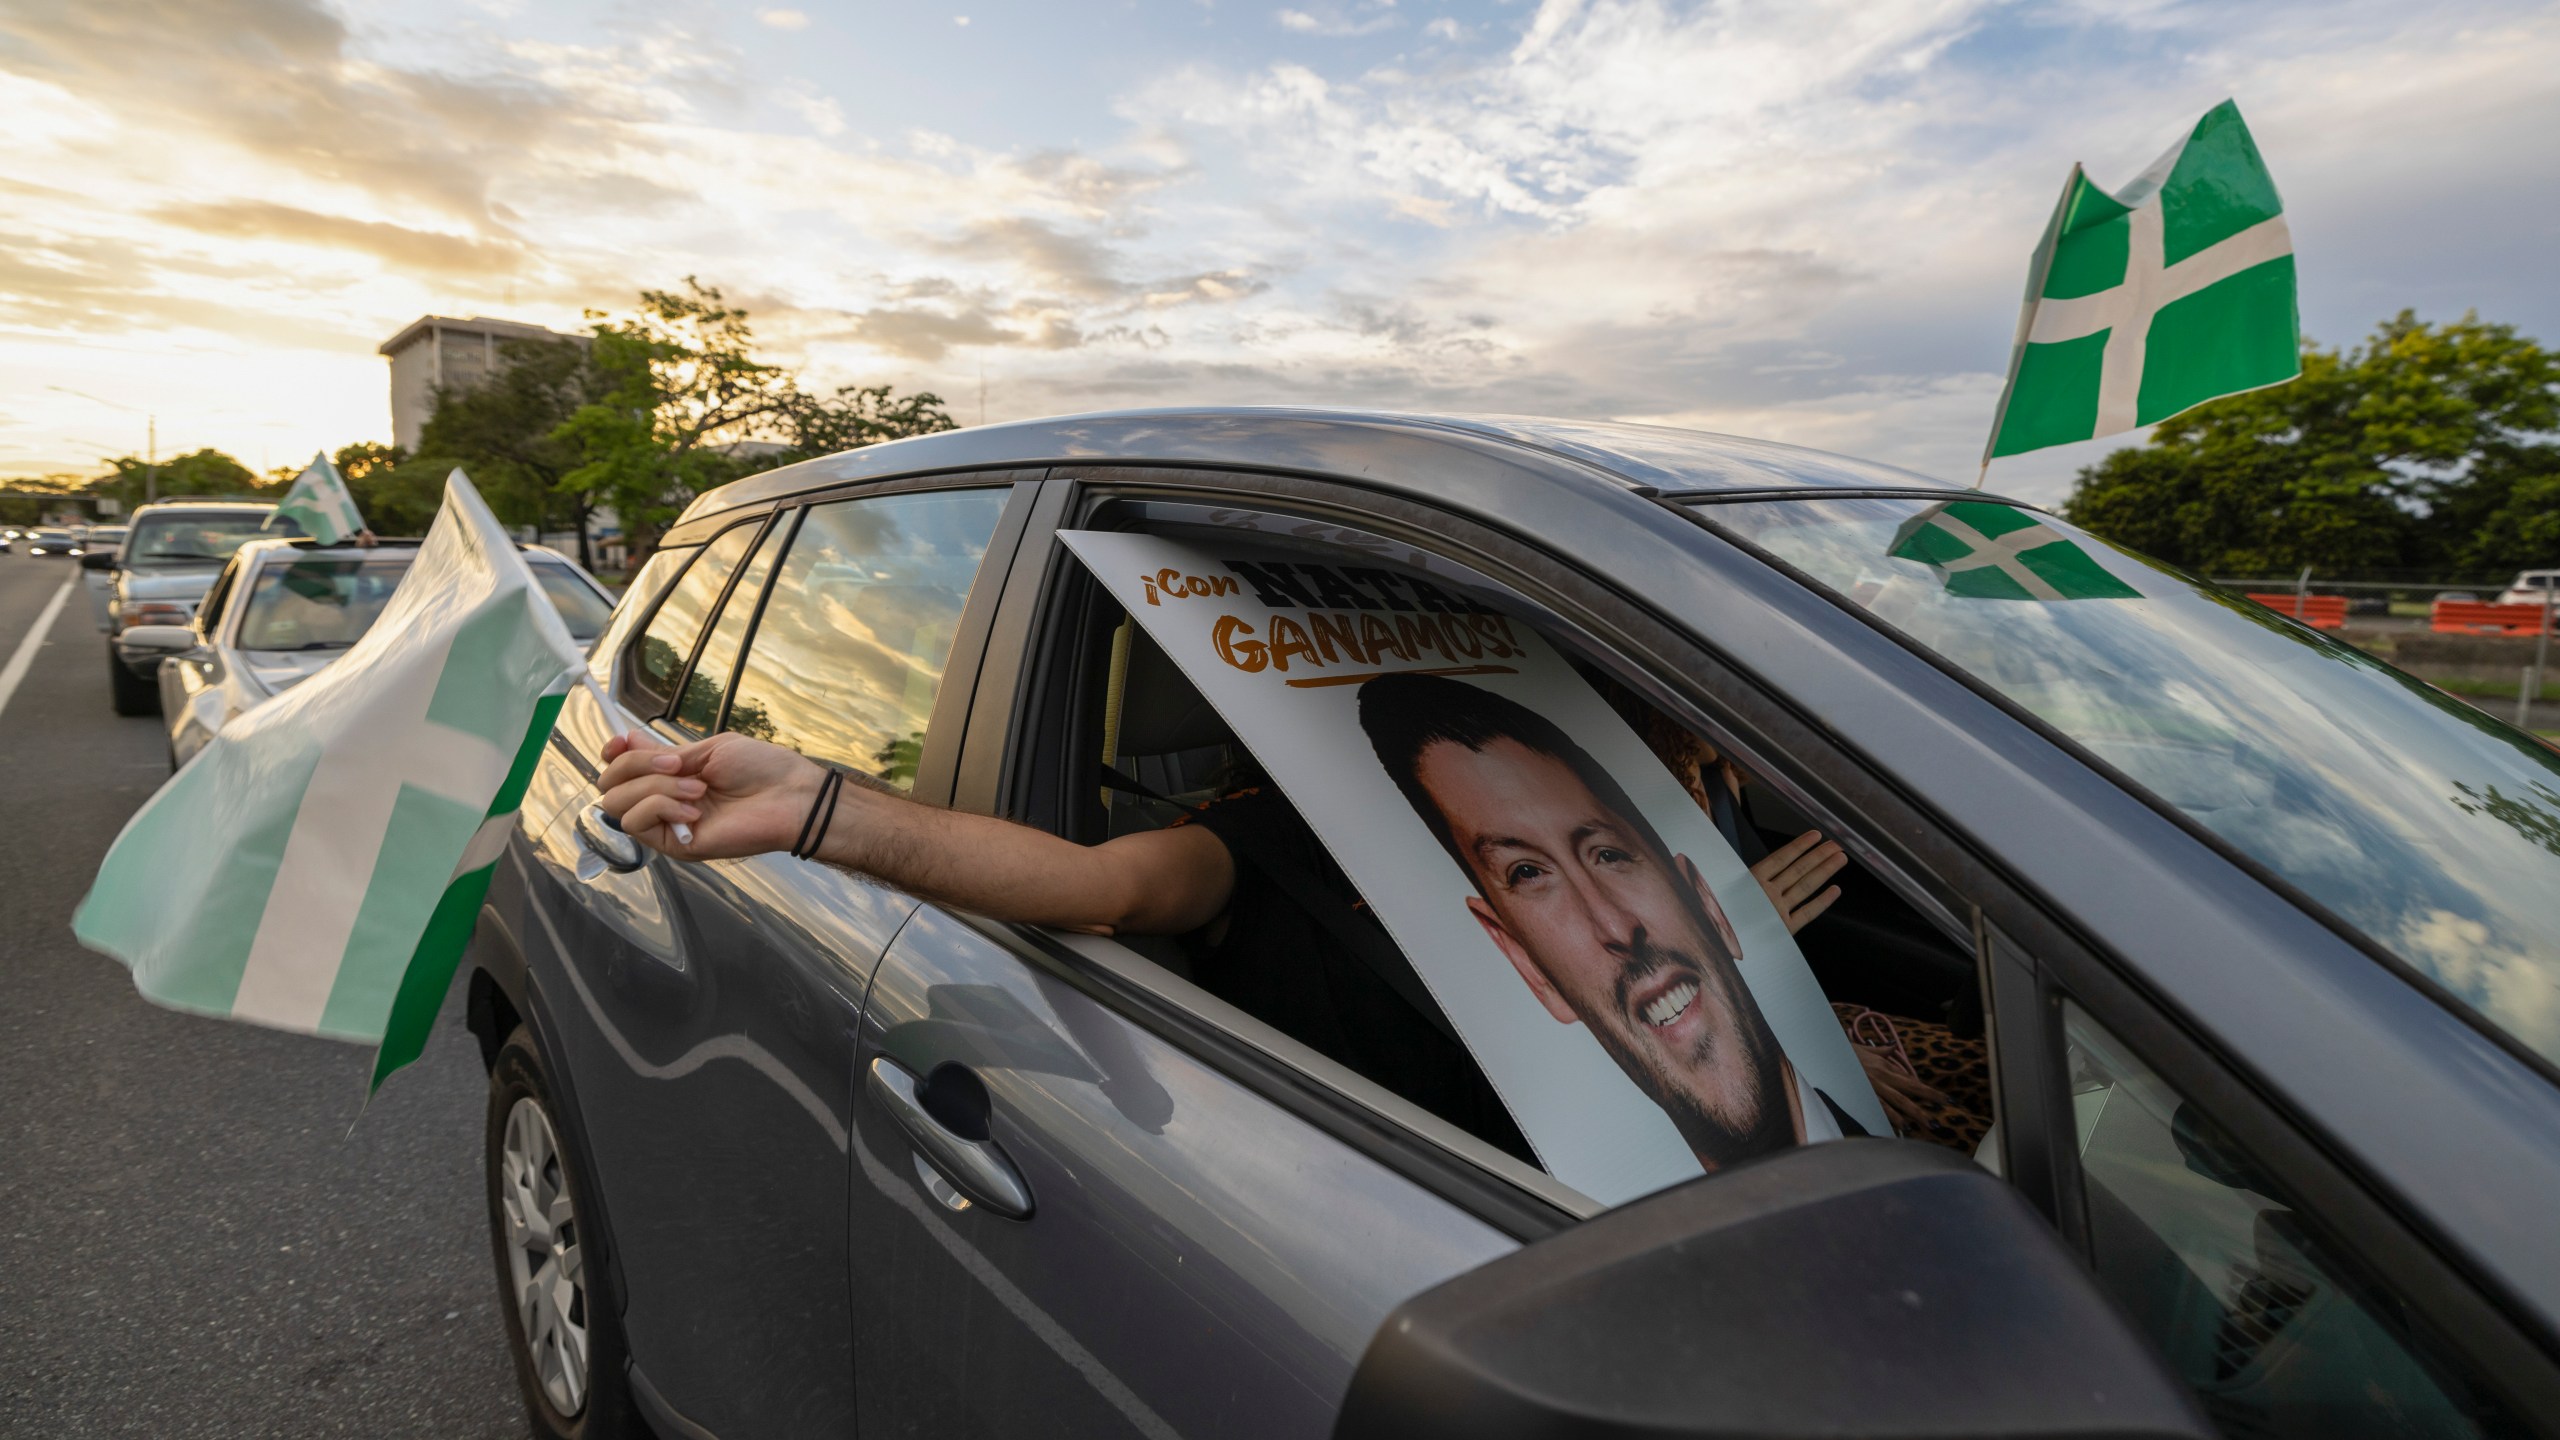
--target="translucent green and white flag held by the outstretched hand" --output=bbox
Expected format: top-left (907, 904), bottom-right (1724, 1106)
top-left (72, 471), bottom-right (586, 1086)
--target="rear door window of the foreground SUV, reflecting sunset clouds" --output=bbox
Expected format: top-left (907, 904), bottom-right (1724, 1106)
top-left (727, 489), bottom-right (1009, 789)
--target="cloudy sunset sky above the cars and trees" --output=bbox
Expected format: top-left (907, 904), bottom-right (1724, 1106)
top-left (0, 0), bottom-right (2560, 500)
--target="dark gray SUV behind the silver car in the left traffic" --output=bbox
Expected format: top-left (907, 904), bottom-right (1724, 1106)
top-left (79, 500), bottom-right (302, 715)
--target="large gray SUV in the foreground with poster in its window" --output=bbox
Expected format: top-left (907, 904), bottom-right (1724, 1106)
top-left (466, 410), bottom-right (2560, 1440)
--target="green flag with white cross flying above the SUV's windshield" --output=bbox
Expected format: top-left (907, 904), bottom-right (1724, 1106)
top-left (1981, 100), bottom-right (2301, 464)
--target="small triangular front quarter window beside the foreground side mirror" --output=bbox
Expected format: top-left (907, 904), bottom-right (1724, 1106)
top-left (2063, 1002), bottom-right (2524, 1440)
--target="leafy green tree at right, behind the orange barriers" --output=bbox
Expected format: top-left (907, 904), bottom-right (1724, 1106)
top-left (2063, 310), bottom-right (2560, 577)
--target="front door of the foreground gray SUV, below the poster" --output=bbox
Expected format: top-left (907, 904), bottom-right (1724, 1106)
top-left (852, 482), bottom-right (1587, 1437)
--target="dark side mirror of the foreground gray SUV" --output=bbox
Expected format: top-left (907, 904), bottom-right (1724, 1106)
top-left (1334, 1140), bottom-right (2214, 1440)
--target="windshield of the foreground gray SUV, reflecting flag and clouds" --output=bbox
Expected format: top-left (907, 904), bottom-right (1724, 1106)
top-left (1700, 500), bottom-right (2560, 1061)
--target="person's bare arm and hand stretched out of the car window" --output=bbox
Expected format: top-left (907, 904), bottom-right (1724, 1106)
top-left (596, 733), bottom-right (1236, 935)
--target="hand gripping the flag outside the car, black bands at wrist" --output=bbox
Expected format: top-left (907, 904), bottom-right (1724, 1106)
top-left (596, 730), bottom-right (827, 861)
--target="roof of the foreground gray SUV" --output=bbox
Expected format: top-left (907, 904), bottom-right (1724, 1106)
top-left (678, 407), bottom-right (1966, 523)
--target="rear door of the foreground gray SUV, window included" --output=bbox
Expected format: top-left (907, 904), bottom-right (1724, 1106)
top-left (509, 474), bottom-right (1027, 1435)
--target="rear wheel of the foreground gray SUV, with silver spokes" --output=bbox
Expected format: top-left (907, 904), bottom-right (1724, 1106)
top-left (481, 1025), bottom-right (650, 1440)
